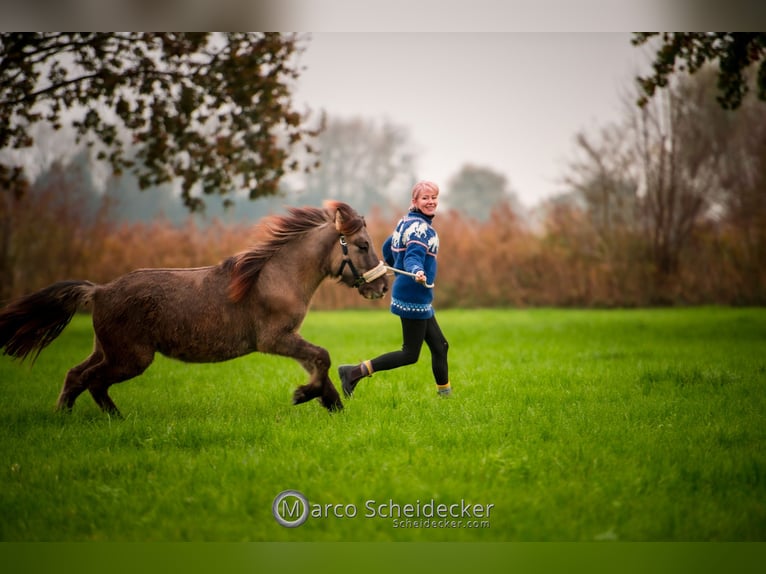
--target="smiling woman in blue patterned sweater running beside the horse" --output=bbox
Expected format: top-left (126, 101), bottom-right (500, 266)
top-left (338, 181), bottom-right (452, 397)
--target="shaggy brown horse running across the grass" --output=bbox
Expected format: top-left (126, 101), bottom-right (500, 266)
top-left (0, 201), bottom-right (388, 417)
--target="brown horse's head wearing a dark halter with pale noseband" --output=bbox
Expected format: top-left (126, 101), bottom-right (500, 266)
top-left (325, 201), bottom-right (388, 299)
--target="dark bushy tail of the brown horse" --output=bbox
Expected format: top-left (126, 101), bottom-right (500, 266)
top-left (0, 281), bottom-right (95, 362)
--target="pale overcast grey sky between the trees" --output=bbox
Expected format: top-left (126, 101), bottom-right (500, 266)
top-left (294, 32), bottom-right (650, 207)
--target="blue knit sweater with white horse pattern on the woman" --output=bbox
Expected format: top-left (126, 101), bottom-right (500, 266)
top-left (382, 211), bottom-right (439, 319)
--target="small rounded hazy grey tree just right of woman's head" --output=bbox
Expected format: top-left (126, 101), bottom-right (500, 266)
top-left (446, 164), bottom-right (519, 221)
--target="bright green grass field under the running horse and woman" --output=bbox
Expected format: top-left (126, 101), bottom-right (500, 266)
top-left (0, 308), bottom-right (766, 541)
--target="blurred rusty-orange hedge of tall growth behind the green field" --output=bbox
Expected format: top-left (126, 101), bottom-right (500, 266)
top-left (0, 170), bottom-right (766, 309)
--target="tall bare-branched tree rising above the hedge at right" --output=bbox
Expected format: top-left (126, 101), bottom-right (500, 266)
top-left (567, 66), bottom-right (740, 300)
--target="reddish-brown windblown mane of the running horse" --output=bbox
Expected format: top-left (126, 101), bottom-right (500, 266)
top-left (225, 200), bottom-right (365, 302)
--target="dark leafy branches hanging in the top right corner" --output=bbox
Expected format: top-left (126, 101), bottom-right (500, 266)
top-left (632, 32), bottom-right (766, 109)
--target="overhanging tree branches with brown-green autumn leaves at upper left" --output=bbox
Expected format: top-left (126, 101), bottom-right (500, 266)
top-left (0, 33), bottom-right (317, 210)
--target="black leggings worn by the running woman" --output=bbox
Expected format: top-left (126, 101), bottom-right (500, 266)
top-left (371, 317), bottom-right (449, 385)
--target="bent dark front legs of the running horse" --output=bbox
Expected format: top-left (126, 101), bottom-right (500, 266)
top-left (264, 333), bottom-right (343, 412)
